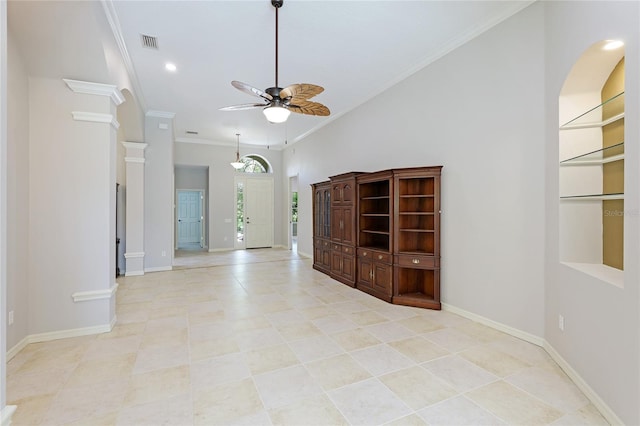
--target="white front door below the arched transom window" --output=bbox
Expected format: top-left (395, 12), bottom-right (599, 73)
top-left (244, 178), bottom-right (273, 248)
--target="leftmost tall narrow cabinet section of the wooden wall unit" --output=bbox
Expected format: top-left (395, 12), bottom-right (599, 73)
top-left (311, 181), bottom-right (331, 273)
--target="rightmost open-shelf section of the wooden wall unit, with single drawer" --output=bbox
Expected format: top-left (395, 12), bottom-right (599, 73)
top-left (393, 167), bottom-right (441, 309)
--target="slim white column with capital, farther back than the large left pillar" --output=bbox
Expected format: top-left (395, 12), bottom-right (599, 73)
top-left (122, 142), bottom-right (147, 276)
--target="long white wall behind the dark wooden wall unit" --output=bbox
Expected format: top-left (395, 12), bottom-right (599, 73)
top-left (285, 4), bottom-right (545, 336)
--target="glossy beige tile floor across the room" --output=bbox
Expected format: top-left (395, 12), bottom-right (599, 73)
top-left (7, 249), bottom-right (606, 426)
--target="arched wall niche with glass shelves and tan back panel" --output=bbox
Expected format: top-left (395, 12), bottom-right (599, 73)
top-left (559, 40), bottom-right (624, 286)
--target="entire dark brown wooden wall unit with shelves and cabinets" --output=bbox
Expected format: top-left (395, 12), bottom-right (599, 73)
top-left (311, 166), bottom-right (442, 309)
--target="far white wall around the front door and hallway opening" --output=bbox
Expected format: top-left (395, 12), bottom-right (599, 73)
top-left (175, 142), bottom-right (287, 250)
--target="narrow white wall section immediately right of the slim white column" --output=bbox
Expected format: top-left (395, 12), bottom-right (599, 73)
top-left (144, 113), bottom-right (174, 271)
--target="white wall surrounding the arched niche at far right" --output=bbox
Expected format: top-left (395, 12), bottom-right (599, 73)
top-left (544, 1), bottom-right (640, 424)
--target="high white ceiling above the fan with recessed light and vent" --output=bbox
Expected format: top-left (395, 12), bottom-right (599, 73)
top-left (9, 0), bottom-right (531, 148)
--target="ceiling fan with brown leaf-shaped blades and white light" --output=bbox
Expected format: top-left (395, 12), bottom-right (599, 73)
top-left (220, 0), bottom-right (330, 123)
